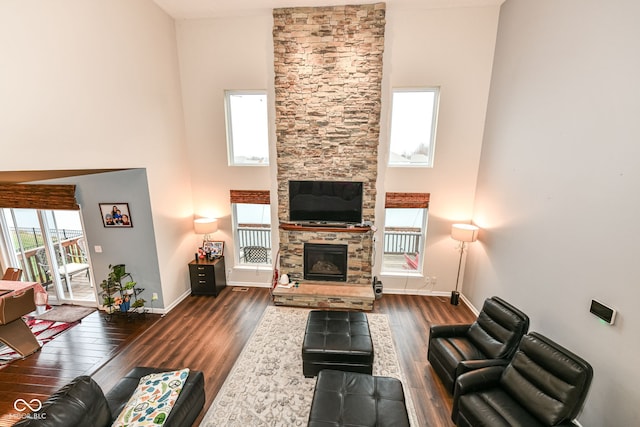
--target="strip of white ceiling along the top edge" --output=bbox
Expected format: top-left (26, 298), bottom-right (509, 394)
top-left (154, 0), bottom-right (505, 19)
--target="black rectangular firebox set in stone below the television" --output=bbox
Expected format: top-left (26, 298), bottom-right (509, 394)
top-left (304, 243), bottom-right (347, 282)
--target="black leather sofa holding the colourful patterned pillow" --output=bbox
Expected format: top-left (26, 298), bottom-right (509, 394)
top-left (14, 367), bottom-right (205, 427)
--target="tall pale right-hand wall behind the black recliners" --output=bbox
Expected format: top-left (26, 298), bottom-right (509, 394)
top-left (464, 0), bottom-right (640, 426)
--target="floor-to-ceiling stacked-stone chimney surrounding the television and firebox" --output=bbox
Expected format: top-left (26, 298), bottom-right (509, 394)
top-left (273, 3), bottom-right (385, 286)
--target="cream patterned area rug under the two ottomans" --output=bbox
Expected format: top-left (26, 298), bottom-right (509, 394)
top-left (200, 306), bottom-right (418, 427)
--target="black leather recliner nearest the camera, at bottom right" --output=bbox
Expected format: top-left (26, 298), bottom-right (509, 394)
top-left (451, 332), bottom-right (593, 427)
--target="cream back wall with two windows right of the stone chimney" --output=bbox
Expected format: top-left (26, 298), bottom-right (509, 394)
top-left (374, 6), bottom-right (499, 293)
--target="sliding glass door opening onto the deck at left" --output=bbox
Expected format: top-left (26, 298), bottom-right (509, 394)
top-left (0, 209), bottom-right (96, 304)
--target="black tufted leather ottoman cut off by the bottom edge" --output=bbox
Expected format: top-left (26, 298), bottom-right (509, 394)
top-left (308, 369), bottom-right (409, 427)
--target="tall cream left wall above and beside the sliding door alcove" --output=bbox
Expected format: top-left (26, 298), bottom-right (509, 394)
top-left (0, 0), bottom-right (194, 304)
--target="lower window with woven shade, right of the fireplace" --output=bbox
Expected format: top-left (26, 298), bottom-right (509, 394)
top-left (382, 193), bottom-right (429, 274)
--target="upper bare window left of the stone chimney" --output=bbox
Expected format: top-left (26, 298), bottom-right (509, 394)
top-left (225, 91), bottom-right (269, 166)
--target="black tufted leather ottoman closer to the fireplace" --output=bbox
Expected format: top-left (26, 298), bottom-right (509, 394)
top-left (302, 310), bottom-right (373, 378)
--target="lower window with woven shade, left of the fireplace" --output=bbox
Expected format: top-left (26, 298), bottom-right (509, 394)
top-left (231, 190), bottom-right (272, 266)
